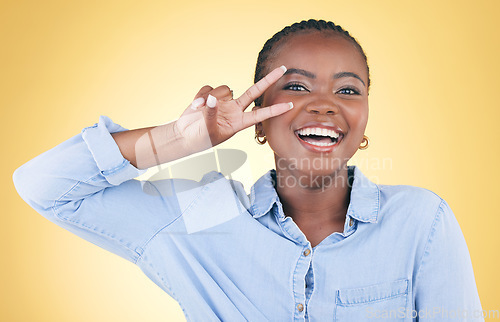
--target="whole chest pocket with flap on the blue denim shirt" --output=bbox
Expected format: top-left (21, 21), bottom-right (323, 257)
top-left (335, 279), bottom-right (411, 322)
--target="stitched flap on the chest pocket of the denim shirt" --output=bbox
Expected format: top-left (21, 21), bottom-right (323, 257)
top-left (337, 279), bottom-right (408, 305)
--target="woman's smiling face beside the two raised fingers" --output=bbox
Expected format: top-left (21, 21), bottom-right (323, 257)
top-left (256, 31), bottom-right (368, 175)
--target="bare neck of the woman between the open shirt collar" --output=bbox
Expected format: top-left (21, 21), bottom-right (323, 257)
top-left (276, 161), bottom-right (351, 226)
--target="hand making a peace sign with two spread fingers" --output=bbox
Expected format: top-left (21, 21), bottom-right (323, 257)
top-left (175, 66), bottom-right (293, 152)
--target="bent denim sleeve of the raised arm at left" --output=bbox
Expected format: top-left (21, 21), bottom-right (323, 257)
top-left (13, 116), bottom-right (184, 263)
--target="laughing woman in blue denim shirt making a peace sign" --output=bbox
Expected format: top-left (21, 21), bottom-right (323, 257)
top-left (14, 20), bottom-right (482, 321)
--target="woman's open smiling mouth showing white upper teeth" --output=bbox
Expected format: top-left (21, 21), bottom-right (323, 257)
top-left (294, 127), bottom-right (344, 152)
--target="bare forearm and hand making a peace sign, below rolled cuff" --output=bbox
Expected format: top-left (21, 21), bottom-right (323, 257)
top-left (112, 66), bottom-right (293, 169)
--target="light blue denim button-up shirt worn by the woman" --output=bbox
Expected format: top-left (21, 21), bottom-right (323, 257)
top-left (14, 116), bottom-right (483, 322)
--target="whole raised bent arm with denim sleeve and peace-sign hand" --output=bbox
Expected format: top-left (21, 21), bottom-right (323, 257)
top-left (13, 68), bottom-right (289, 263)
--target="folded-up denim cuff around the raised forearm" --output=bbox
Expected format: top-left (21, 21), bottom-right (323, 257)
top-left (82, 115), bottom-right (147, 185)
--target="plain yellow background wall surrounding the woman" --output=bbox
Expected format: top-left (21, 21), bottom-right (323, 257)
top-left (0, 0), bottom-right (500, 322)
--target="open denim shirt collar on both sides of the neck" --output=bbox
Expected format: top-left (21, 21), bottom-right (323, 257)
top-left (250, 165), bottom-right (380, 223)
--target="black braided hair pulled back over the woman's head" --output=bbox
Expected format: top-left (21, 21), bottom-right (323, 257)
top-left (254, 19), bottom-right (370, 106)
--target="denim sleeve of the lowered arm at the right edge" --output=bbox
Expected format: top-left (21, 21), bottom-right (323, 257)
top-left (414, 200), bottom-right (484, 321)
